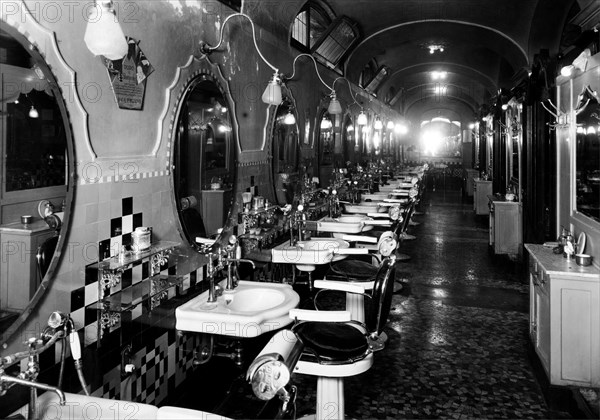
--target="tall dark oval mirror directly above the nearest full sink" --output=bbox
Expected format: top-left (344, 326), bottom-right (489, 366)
top-left (172, 72), bottom-right (237, 246)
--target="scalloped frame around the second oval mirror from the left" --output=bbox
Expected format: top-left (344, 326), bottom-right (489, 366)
top-left (163, 55), bottom-right (240, 249)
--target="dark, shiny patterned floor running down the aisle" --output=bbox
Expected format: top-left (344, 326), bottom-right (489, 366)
top-left (169, 191), bottom-right (596, 419)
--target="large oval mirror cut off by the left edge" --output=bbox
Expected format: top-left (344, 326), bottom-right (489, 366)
top-left (0, 21), bottom-right (73, 344)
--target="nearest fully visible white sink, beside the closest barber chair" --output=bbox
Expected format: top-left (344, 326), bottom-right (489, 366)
top-left (175, 280), bottom-right (300, 337)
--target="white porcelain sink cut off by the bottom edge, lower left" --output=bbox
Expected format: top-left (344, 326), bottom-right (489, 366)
top-left (13, 392), bottom-right (226, 420)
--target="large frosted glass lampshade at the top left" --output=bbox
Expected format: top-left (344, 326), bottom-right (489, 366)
top-left (83, 0), bottom-right (129, 60)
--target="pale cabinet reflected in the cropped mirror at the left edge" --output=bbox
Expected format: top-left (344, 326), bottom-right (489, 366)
top-left (0, 220), bottom-right (54, 311)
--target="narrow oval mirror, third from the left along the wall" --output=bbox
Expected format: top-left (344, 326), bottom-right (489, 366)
top-left (271, 98), bottom-right (300, 205)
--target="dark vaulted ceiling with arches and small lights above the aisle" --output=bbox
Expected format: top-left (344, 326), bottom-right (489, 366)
top-left (327, 0), bottom-right (598, 122)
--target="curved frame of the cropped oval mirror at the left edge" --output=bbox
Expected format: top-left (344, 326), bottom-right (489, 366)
top-left (0, 9), bottom-right (77, 348)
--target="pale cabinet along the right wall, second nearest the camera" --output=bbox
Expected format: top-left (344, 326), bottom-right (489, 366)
top-left (488, 196), bottom-right (523, 256)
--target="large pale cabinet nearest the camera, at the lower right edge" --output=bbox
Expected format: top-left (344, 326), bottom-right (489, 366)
top-left (525, 244), bottom-right (600, 387)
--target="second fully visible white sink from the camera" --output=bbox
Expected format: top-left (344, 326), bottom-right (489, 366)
top-left (271, 238), bottom-right (350, 271)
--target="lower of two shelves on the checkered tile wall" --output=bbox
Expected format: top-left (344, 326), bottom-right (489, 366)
top-left (96, 274), bottom-right (183, 312)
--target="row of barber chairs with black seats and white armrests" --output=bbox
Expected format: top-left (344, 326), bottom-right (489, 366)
top-left (247, 178), bottom-right (423, 420)
